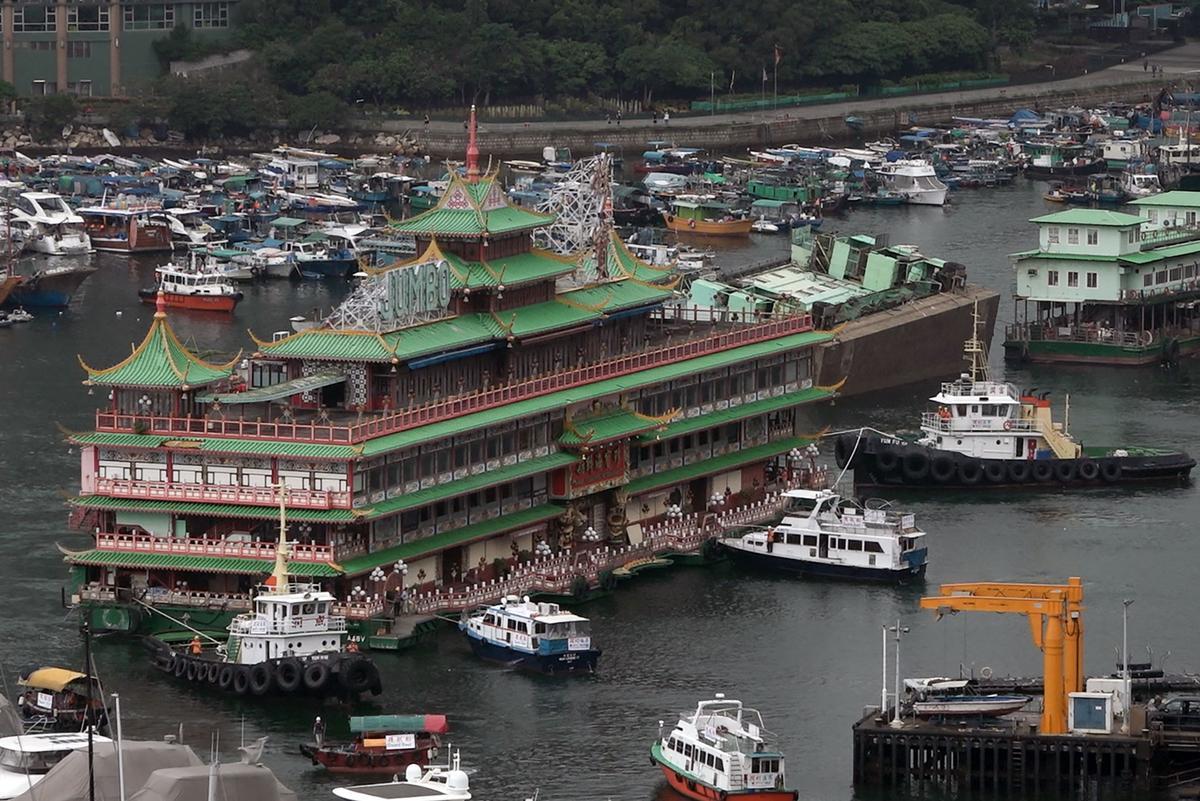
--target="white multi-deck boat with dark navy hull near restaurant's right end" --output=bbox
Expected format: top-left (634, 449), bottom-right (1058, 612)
top-left (718, 489), bottom-right (929, 582)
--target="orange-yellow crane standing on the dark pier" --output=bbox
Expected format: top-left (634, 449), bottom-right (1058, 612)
top-left (920, 577), bottom-right (1084, 734)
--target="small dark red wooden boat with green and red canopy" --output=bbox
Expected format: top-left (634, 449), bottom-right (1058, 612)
top-left (300, 715), bottom-right (450, 775)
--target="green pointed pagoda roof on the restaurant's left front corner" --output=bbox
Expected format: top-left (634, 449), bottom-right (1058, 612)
top-left (79, 298), bottom-right (241, 390)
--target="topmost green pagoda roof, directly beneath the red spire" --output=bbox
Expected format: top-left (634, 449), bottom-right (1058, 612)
top-left (391, 173), bottom-right (554, 239)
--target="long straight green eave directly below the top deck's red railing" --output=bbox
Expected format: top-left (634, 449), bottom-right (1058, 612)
top-left (362, 331), bottom-right (833, 456)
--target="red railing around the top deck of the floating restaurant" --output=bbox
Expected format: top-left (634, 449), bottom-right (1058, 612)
top-left (96, 314), bottom-right (812, 445)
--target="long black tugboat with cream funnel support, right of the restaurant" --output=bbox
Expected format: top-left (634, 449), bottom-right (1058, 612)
top-left (834, 306), bottom-right (1196, 489)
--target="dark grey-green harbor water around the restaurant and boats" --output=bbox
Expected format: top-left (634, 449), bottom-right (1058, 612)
top-left (0, 180), bottom-right (1200, 801)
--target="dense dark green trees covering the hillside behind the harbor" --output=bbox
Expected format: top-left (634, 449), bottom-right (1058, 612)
top-left (231, 0), bottom-right (1033, 109)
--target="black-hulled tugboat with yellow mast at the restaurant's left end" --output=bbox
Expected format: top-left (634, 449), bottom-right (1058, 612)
top-left (148, 486), bottom-right (382, 698)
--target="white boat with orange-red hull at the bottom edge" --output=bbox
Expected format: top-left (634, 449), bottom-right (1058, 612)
top-left (650, 693), bottom-right (797, 801)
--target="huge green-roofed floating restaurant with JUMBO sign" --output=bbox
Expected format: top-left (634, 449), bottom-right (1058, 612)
top-left (64, 125), bottom-right (836, 633)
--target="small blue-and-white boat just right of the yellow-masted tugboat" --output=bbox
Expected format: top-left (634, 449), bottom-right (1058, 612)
top-left (458, 595), bottom-right (600, 673)
